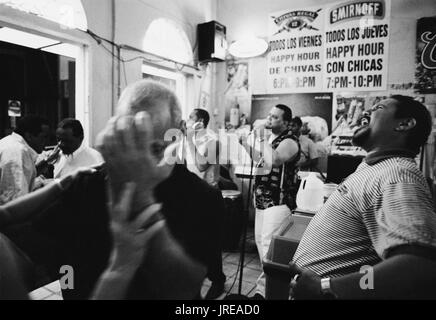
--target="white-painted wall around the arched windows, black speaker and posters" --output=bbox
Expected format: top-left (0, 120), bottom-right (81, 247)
top-left (5, 0), bottom-right (436, 144)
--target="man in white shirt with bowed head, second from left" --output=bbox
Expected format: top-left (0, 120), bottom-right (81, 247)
top-left (53, 118), bottom-right (103, 178)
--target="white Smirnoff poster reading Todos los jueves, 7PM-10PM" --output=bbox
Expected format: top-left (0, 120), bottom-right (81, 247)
top-left (323, 1), bottom-right (390, 91)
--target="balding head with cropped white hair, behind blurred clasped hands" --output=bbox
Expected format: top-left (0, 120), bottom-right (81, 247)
top-left (117, 80), bottom-right (182, 139)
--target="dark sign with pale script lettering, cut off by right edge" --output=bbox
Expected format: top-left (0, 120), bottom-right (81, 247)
top-left (415, 17), bottom-right (436, 93)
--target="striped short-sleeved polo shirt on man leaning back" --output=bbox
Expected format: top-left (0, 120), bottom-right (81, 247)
top-left (293, 156), bottom-right (436, 277)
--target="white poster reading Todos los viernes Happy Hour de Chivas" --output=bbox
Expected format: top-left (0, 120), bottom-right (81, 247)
top-left (267, 7), bottom-right (325, 93)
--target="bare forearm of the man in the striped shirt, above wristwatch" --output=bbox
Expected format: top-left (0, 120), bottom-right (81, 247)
top-left (331, 254), bottom-right (436, 299)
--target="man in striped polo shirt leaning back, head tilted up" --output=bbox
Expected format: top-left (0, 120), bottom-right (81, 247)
top-left (291, 95), bottom-right (436, 299)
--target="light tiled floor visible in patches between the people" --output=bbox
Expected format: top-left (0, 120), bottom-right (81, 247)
top-left (30, 228), bottom-right (261, 300)
